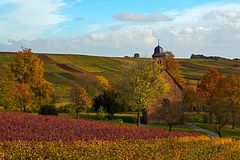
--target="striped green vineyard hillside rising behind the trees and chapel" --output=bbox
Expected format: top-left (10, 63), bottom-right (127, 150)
top-left (0, 53), bottom-right (240, 92)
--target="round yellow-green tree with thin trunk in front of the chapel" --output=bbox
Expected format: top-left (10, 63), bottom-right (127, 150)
top-left (118, 59), bottom-right (168, 126)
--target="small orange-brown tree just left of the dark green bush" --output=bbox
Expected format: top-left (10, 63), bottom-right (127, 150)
top-left (70, 84), bottom-right (92, 118)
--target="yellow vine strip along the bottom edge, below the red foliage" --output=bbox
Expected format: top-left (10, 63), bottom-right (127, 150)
top-left (0, 137), bottom-right (240, 160)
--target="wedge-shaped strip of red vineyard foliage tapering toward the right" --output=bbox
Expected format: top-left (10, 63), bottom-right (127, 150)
top-left (0, 111), bottom-right (198, 141)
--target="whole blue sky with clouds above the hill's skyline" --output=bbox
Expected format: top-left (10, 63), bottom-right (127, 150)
top-left (0, 0), bottom-right (240, 58)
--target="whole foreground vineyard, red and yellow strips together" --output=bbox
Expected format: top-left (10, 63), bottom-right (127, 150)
top-left (0, 111), bottom-right (240, 160)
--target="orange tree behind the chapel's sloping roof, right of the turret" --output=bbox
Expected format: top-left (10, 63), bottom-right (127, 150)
top-left (164, 51), bottom-right (185, 86)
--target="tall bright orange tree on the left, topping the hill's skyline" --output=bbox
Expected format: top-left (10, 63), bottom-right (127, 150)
top-left (10, 48), bottom-right (52, 111)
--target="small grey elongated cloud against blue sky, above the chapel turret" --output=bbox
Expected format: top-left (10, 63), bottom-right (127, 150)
top-left (113, 12), bottom-right (171, 23)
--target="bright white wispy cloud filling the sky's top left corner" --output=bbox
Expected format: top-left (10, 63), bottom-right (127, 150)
top-left (0, 0), bottom-right (66, 42)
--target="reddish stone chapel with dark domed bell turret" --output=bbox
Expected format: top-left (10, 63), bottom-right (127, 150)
top-left (144, 43), bottom-right (183, 124)
